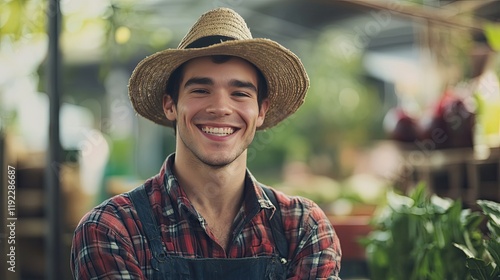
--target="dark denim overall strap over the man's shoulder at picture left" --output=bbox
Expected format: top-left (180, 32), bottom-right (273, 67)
top-left (128, 185), bottom-right (167, 271)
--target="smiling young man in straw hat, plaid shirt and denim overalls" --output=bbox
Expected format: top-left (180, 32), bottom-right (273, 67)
top-left (71, 8), bottom-right (341, 279)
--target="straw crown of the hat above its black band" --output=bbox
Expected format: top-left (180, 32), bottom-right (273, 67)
top-left (178, 8), bottom-right (252, 49)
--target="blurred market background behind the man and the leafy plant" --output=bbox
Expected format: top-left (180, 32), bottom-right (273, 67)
top-left (0, 0), bottom-right (500, 279)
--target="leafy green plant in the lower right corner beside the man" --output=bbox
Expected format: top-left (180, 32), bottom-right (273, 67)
top-left (361, 183), bottom-right (492, 280)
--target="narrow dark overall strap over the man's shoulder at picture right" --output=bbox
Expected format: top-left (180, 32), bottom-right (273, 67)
top-left (261, 185), bottom-right (288, 263)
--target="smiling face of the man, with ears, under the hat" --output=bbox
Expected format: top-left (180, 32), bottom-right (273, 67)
top-left (164, 57), bottom-right (268, 167)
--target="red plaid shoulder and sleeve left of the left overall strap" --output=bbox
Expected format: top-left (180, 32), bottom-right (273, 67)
top-left (71, 189), bottom-right (150, 279)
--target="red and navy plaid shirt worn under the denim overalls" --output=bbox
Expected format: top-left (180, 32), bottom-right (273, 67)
top-left (71, 155), bottom-right (341, 279)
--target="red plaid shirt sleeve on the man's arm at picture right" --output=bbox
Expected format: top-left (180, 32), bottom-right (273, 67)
top-left (287, 203), bottom-right (342, 280)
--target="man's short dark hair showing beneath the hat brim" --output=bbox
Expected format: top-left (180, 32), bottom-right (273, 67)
top-left (166, 55), bottom-right (269, 110)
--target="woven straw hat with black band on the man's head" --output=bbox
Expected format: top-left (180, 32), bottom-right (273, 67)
top-left (128, 8), bottom-right (309, 130)
